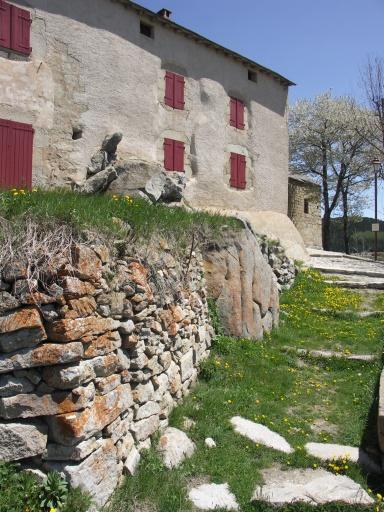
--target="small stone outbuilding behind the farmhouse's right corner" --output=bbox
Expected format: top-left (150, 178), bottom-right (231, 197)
top-left (288, 174), bottom-right (323, 249)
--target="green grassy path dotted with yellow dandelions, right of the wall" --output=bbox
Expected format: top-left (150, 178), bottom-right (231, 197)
top-left (106, 272), bottom-right (382, 512)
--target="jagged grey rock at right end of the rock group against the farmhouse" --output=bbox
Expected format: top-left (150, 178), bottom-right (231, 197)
top-left (145, 171), bottom-right (187, 203)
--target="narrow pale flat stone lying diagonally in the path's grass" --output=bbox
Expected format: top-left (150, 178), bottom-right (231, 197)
top-left (231, 416), bottom-right (294, 453)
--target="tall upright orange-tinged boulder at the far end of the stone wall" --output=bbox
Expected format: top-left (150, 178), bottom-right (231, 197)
top-left (204, 228), bottom-right (279, 339)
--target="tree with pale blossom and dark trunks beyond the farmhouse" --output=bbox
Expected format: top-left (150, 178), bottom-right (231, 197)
top-left (289, 92), bottom-right (372, 252)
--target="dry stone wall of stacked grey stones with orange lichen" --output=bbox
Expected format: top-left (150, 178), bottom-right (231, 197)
top-left (0, 245), bottom-right (212, 505)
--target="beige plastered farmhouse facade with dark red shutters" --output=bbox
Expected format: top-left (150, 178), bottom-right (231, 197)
top-left (0, 0), bottom-right (292, 215)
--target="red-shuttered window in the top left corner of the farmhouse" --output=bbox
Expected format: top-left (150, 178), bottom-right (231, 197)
top-left (0, 0), bottom-right (32, 55)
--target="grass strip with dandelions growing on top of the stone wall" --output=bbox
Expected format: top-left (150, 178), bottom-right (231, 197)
top-left (0, 189), bottom-right (240, 248)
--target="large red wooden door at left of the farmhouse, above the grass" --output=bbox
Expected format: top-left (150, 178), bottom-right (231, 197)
top-left (0, 119), bottom-right (33, 188)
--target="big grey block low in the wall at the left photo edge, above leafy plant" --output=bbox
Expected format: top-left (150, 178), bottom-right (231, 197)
top-left (0, 421), bottom-right (47, 461)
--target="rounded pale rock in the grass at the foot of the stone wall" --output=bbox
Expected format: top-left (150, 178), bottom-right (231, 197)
top-left (158, 427), bottom-right (196, 469)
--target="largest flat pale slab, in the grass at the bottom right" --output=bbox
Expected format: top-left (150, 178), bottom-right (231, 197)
top-left (252, 468), bottom-right (374, 506)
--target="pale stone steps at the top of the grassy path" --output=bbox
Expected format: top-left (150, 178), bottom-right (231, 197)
top-left (306, 249), bottom-right (384, 290)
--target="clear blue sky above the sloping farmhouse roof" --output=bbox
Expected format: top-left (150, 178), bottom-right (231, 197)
top-left (138, 0), bottom-right (384, 101)
